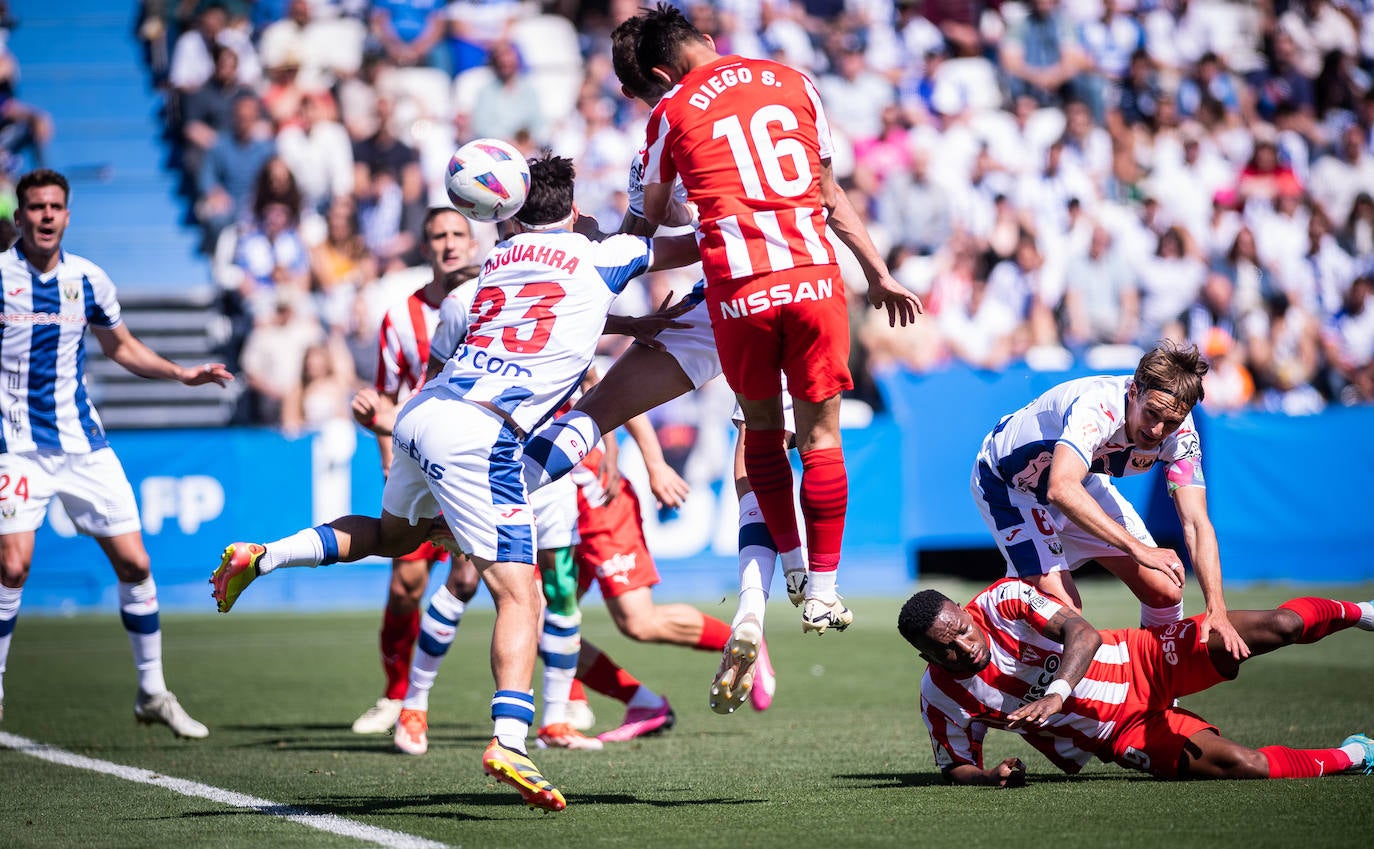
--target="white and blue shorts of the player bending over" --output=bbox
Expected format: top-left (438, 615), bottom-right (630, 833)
top-left (970, 462), bottom-right (1154, 578)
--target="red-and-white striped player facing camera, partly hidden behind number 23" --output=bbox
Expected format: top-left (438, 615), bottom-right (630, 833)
top-left (343, 206), bottom-right (477, 734)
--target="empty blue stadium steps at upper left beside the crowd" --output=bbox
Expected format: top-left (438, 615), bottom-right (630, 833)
top-left (10, 0), bottom-right (210, 297)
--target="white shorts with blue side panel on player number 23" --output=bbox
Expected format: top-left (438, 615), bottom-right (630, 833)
top-left (382, 397), bottom-right (537, 565)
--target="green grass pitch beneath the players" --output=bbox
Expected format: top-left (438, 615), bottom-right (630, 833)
top-left (0, 574), bottom-right (1374, 849)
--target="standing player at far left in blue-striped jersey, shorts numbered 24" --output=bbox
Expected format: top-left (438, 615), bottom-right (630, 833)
top-left (0, 169), bottom-right (234, 738)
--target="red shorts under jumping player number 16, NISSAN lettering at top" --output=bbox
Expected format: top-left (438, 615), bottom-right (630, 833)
top-left (706, 265), bottom-right (855, 403)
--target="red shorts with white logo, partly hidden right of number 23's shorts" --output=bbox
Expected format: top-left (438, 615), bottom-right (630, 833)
top-left (573, 481), bottom-right (658, 599)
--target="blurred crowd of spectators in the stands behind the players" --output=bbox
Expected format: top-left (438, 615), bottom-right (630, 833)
top-left (123, 0), bottom-right (1374, 426)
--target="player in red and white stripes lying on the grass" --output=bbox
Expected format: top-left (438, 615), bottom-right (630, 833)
top-left (897, 578), bottom-right (1374, 787)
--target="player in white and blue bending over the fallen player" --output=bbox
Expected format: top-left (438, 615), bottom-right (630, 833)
top-left (971, 336), bottom-right (1246, 658)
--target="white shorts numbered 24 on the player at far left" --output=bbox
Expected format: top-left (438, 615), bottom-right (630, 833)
top-left (0, 446), bottom-right (143, 539)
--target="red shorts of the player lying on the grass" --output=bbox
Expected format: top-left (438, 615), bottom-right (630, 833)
top-left (1112, 615), bottom-right (1227, 779)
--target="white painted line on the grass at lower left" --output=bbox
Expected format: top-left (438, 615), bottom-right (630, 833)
top-left (0, 731), bottom-right (448, 849)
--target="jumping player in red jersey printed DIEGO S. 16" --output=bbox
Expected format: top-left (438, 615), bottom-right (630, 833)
top-left (636, 4), bottom-right (921, 632)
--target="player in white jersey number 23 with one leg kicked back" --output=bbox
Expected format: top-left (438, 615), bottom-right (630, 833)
top-left (210, 157), bottom-right (698, 811)
